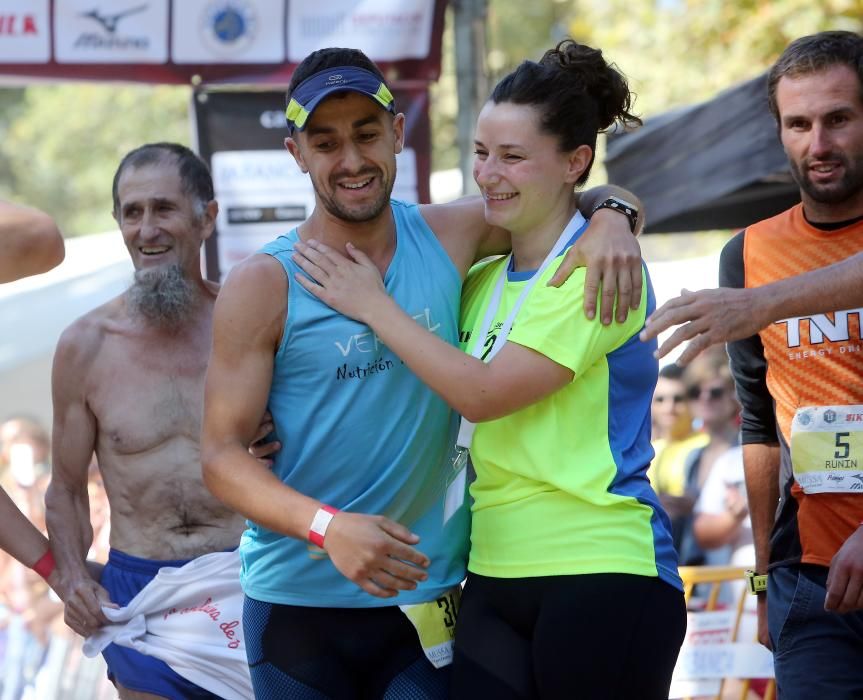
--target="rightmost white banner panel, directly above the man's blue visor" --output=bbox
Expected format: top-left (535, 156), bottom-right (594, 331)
top-left (288, 0), bottom-right (434, 63)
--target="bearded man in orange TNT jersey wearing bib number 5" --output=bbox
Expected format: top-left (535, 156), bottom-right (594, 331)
top-left (720, 32), bottom-right (863, 700)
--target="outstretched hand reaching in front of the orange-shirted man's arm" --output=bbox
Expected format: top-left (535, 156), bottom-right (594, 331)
top-left (640, 287), bottom-right (770, 366)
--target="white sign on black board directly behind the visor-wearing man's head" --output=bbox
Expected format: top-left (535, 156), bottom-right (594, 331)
top-left (212, 148), bottom-right (418, 279)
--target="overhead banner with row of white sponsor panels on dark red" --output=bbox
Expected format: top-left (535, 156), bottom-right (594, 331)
top-left (0, 0), bottom-right (448, 82)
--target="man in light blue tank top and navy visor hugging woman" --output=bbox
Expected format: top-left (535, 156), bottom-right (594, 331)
top-left (202, 49), bottom-right (641, 700)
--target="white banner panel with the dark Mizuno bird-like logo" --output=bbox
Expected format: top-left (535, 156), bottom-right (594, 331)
top-left (54, 0), bottom-right (168, 63)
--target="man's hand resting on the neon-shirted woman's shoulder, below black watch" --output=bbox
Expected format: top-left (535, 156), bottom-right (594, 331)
top-left (548, 211), bottom-right (642, 326)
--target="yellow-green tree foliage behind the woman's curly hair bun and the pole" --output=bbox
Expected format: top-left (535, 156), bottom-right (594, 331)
top-left (433, 0), bottom-right (863, 174)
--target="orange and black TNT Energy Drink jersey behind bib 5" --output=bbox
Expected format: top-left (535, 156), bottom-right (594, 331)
top-left (743, 204), bottom-right (863, 566)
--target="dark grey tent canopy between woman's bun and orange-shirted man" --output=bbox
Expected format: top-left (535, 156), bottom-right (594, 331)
top-left (605, 73), bottom-right (800, 233)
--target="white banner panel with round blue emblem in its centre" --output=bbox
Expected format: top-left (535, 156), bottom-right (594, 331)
top-left (171, 0), bottom-right (285, 64)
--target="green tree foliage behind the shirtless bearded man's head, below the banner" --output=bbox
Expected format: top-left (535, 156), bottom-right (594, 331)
top-left (0, 83), bottom-right (191, 235)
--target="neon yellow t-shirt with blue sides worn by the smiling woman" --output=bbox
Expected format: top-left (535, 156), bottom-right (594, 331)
top-left (459, 257), bottom-right (681, 588)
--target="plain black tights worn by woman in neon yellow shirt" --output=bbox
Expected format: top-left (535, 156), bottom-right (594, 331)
top-left (452, 574), bottom-right (686, 700)
